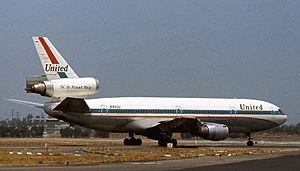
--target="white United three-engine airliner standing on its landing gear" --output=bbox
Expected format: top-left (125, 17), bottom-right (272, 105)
top-left (10, 36), bottom-right (287, 146)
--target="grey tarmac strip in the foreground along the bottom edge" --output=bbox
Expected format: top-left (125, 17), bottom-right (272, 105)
top-left (0, 151), bottom-right (300, 171)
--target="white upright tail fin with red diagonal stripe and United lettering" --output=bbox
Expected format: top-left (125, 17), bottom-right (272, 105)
top-left (32, 37), bottom-right (78, 80)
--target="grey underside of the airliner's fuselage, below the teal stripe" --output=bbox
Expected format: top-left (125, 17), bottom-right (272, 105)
top-left (56, 113), bottom-right (278, 133)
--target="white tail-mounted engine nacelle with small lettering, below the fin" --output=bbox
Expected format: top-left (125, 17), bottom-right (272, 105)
top-left (26, 77), bottom-right (99, 98)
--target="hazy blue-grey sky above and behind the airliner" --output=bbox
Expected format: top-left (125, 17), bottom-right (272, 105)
top-left (0, 0), bottom-right (300, 123)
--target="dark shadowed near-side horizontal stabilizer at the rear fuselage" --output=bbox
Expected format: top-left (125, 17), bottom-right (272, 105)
top-left (54, 97), bottom-right (91, 113)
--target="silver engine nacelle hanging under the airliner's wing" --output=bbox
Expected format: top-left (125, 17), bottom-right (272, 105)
top-left (194, 123), bottom-right (229, 141)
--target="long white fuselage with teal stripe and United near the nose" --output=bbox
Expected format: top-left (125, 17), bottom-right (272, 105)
top-left (44, 97), bottom-right (287, 133)
